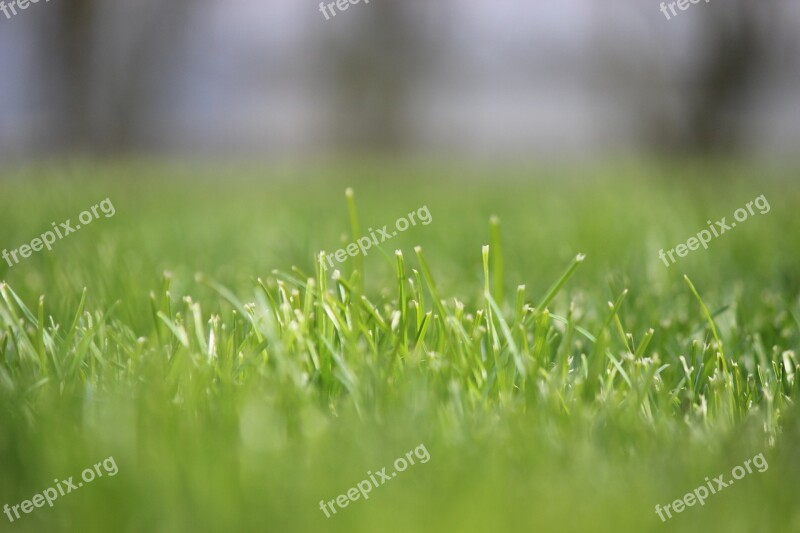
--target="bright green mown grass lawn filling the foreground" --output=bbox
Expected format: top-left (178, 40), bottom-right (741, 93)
top-left (0, 162), bottom-right (800, 533)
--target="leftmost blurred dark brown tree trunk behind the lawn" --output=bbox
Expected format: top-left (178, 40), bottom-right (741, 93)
top-left (41, 0), bottom-right (197, 153)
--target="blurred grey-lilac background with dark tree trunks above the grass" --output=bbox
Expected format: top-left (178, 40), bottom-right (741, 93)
top-left (0, 0), bottom-right (800, 164)
